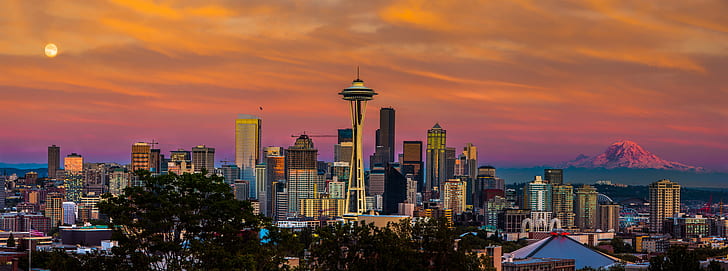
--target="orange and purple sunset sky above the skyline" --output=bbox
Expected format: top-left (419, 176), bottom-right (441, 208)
top-left (0, 0), bottom-right (728, 170)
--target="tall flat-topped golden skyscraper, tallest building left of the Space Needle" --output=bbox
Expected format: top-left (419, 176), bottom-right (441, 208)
top-left (235, 114), bottom-right (262, 185)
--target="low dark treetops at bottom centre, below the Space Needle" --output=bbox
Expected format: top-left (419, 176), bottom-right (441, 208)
top-left (308, 220), bottom-right (491, 270)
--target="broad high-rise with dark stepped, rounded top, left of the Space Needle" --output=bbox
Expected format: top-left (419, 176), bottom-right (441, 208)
top-left (285, 135), bottom-right (318, 216)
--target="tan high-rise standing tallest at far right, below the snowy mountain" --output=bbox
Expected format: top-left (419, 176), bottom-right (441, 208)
top-left (650, 179), bottom-right (680, 233)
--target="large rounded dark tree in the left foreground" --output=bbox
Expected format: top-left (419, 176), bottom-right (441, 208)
top-left (98, 171), bottom-right (282, 270)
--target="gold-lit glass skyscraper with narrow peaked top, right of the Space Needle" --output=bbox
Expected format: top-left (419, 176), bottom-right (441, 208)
top-left (425, 123), bottom-right (447, 191)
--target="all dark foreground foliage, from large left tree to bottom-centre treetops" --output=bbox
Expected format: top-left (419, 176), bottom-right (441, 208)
top-left (27, 171), bottom-right (506, 271)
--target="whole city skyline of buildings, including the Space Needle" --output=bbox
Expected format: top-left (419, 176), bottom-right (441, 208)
top-left (0, 79), bottom-right (728, 270)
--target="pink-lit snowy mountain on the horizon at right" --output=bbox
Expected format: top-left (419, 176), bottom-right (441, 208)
top-left (564, 140), bottom-right (705, 172)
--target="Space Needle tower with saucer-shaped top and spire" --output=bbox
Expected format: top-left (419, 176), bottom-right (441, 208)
top-left (339, 70), bottom-right (377, 216)
